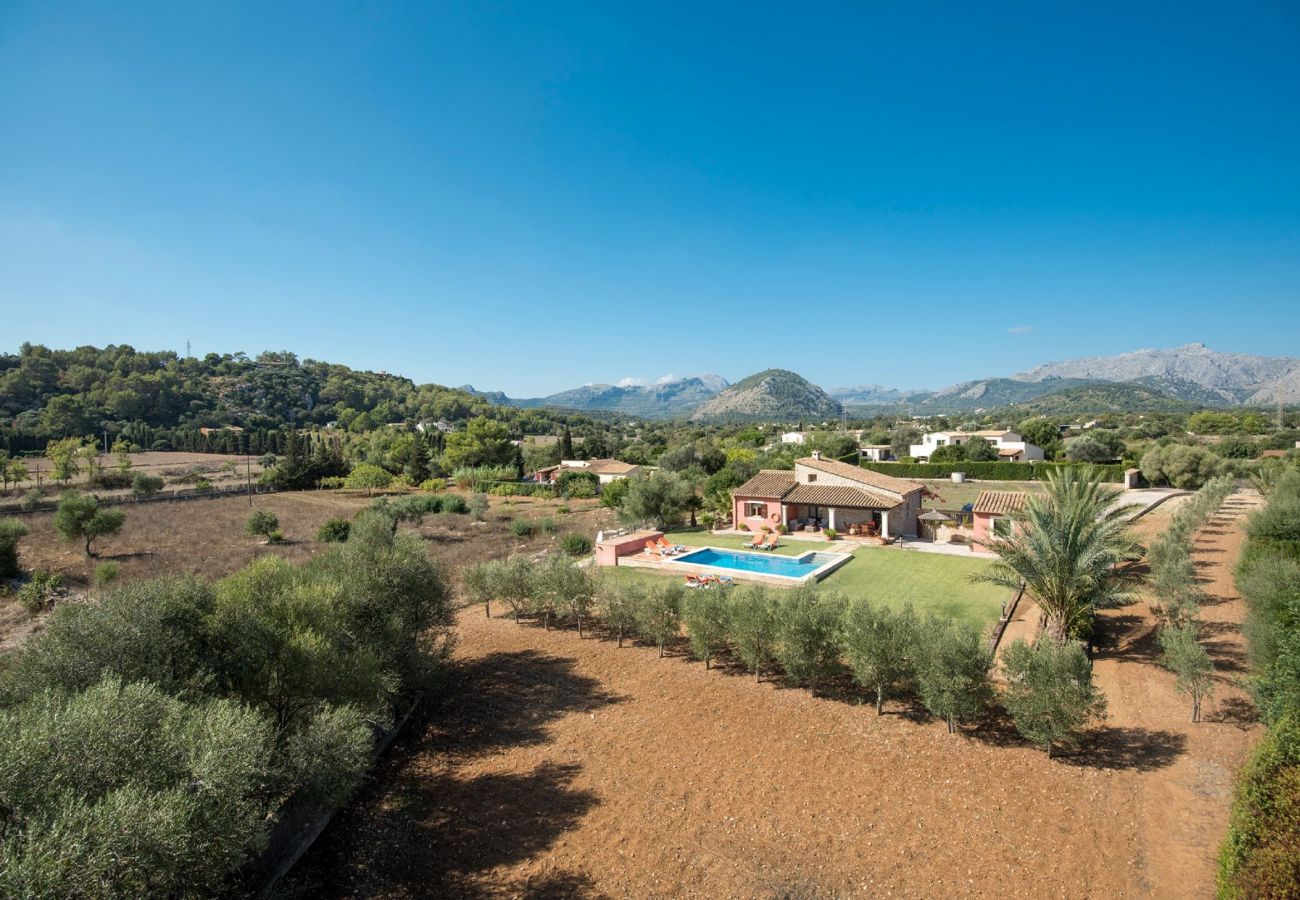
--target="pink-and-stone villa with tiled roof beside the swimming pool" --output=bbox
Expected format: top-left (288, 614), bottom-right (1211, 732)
top-left (732, 451), bottom-right (923, 537)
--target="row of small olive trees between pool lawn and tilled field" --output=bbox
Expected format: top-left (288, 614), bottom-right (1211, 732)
top-left (464, 557), bottom-right (1102, 752)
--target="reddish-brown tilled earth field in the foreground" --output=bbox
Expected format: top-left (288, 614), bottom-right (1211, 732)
top-left (286, 494), bottom-right (1256, 897)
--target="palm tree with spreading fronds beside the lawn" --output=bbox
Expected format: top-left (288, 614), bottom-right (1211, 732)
top-left (971, 468), bottom-right (1140, 644)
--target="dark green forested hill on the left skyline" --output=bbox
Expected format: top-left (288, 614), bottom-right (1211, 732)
top-left (0, 343), bottom-right (566, 440)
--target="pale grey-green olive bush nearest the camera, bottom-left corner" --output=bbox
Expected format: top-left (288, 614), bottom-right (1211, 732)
top-left (0, 679), bottom-right (274, 897)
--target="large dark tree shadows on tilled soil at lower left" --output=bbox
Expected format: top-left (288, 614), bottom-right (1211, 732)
top-left (283, 650), bottom-right (623, 897)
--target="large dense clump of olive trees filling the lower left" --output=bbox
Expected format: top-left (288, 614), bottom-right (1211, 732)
top-left (0, 514), bottom-right (451, 897)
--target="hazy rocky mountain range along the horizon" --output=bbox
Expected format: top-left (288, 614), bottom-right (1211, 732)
top-left (473, 343), bottom-right (1300, 421)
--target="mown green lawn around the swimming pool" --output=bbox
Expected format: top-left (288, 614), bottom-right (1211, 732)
top-left (603, 522), bottom-right (1009, 627)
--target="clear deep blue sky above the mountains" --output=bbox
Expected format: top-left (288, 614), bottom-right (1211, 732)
top-left (0, 0), bottom-right (1300, 397)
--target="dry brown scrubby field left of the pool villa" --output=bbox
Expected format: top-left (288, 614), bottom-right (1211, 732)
top-left (0, 486), bottom-right (612, 652)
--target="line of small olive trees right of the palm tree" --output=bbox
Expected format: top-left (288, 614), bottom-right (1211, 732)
top-left (1148, 476), bottom-right (1234, 722)
